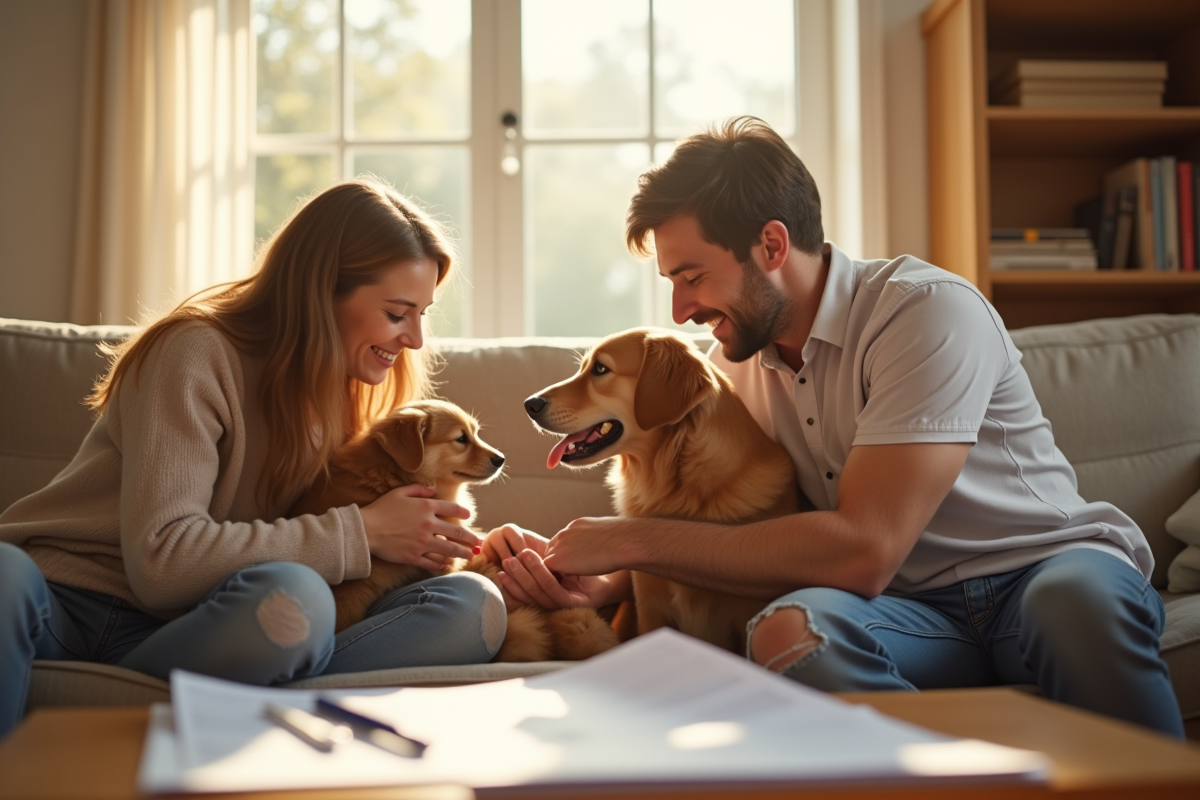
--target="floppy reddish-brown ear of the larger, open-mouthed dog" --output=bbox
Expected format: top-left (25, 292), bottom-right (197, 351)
top-left (634, 333), bottom-right (718, 431)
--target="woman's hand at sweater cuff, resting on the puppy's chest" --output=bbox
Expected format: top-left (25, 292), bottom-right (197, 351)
top-left (361, 483), bottom-right (482, 572)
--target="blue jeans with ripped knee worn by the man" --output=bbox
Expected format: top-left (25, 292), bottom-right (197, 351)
top-left (749, 548), bottom-right (1183, 738)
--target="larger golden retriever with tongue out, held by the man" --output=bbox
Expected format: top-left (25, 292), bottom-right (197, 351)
top-left (526, 329), bottom-right (800, 655)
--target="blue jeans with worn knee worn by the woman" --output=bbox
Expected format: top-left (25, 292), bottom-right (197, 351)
top-left (0, 542), bottom-right (506, 739)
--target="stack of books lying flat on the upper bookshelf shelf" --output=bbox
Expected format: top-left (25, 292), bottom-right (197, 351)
top-left (991, 59), bottom-right (1166, 108)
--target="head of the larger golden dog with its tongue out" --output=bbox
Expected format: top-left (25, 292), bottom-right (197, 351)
top-left (524, 327), bottom-right (720, 469)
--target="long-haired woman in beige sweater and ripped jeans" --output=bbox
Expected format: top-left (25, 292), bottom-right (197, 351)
top-left (0, 181), bottom-right (505, 736)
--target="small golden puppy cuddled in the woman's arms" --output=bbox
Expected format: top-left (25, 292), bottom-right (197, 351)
top-left (290, 399), bottom-right (618, 661)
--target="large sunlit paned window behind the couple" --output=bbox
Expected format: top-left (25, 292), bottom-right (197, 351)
top-left (254, 0), bottom-right (821, 336)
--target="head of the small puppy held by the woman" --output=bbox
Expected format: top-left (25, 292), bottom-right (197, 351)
top-left (367, 399), bottom-right (504, 486)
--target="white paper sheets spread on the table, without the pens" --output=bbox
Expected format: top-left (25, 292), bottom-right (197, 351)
top-left (139, 628), bottom-right (1048, 793)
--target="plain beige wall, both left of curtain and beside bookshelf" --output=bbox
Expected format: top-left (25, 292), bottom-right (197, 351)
top-left (0, 0), bottom-right (930, 320)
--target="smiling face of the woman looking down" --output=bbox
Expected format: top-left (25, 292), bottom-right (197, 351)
top-left (334, 258), bottom-right (438, 386)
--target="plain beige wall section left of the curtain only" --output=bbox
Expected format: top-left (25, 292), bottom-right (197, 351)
top-left (0, 0), bottom-right (89, 320)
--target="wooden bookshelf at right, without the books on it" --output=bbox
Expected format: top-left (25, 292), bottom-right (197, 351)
top-left (922, 0), bottom-right (1200, 327)
